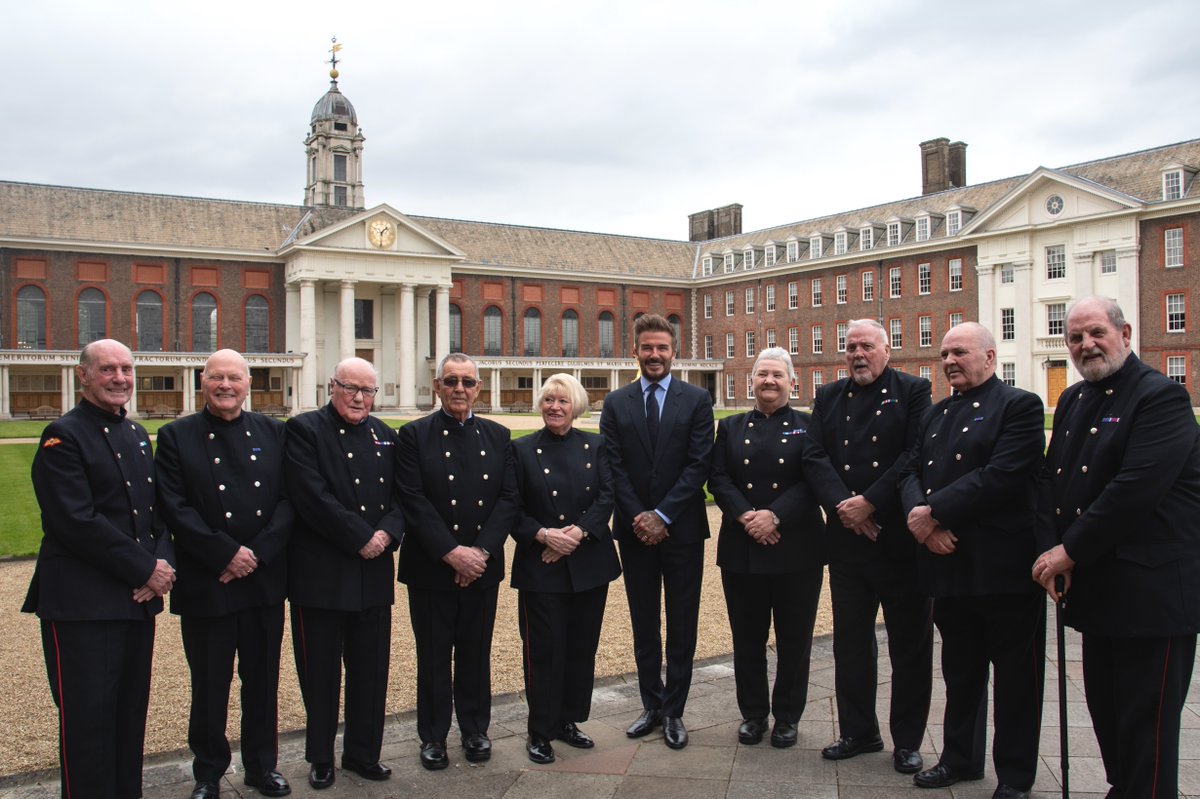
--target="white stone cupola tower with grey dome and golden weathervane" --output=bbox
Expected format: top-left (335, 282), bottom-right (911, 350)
top-left (304, 40), bottom-right (366, 209)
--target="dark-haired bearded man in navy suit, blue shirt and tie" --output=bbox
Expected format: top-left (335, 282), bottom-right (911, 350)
top-left (600, 314), bottom-right (713, 749)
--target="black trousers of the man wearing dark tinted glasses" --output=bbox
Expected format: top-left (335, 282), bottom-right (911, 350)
top-left (408, 585), bottom-right (499, 743)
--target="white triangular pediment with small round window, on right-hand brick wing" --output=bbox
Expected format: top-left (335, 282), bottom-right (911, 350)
top-left (961, 167), bottom-right (1144, 234)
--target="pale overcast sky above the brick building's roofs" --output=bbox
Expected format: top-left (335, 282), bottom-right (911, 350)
top-left (0, 0), bottom-right (1200, 239)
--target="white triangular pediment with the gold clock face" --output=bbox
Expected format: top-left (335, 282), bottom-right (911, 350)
top-left (280, 204), bottom-right (466, 260)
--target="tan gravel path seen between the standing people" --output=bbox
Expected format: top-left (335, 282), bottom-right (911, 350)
top-left (0, 503), bottom-right (833, 776)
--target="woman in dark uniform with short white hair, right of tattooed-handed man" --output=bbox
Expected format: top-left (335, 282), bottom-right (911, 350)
top-left (708, 347), bottom-right (826, 747)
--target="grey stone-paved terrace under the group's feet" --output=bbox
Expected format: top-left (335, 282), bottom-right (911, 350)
top-left (0, 608), bottom-right (1200, 799)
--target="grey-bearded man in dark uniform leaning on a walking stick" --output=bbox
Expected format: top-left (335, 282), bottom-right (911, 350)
top-left (1033, 298), bottom-right (1200, 799)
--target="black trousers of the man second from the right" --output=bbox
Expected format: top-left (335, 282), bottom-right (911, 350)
top-left (934, 591), bottom-right (1046, 791)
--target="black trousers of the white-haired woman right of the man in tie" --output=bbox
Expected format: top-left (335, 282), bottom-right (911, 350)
top-left (721, 566), bottom-right (824, 723)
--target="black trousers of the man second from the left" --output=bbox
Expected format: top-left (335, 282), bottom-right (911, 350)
top-left (179, 605), bottom-right (283, 782)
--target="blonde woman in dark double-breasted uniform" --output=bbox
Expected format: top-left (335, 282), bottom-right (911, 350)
top-left (512, 374), bottom-right (620, 763)
